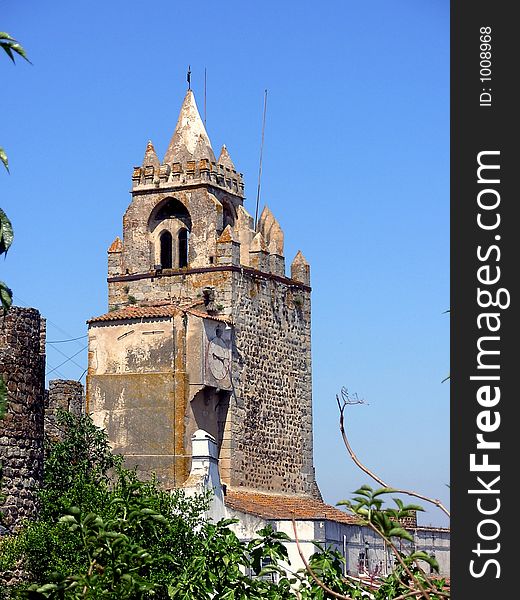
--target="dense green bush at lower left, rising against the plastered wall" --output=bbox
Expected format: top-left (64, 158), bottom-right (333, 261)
top-left (0, 412), bottom-right (292, 599)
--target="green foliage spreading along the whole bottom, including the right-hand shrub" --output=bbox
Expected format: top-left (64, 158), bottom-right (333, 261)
top-left (0, 412), bottom-right (447, 600)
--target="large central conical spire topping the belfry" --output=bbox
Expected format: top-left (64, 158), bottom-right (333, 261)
top-left (164, 90), bottom-right (216, 164)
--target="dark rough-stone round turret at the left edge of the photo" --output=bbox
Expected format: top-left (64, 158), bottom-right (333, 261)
top-left (0, 307), bottom-right (45, 531)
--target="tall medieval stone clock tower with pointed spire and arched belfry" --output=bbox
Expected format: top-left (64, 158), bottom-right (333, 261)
top-left (87, 90), bottom-right (319, 497)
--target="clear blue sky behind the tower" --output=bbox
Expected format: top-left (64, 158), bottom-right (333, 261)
top-left (0, 0), bottom-right (449, 525)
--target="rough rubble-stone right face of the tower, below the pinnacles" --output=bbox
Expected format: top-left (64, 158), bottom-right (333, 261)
top-left (230, 274), bottom-right (319, 497)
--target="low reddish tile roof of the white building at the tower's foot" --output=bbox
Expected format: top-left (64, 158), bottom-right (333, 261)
top-left (224, 489), bottom-right (359, 525)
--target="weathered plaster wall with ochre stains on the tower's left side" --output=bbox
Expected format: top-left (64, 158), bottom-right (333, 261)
top-left (87, 317), bottom-right (189, 487)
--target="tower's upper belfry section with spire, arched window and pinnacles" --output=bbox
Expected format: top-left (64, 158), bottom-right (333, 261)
top-left (108, 90), bottom-right (309, 308)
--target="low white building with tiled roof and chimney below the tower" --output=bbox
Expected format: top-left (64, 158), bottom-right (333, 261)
top-left (184, 430), bottom-right (450, 576)
